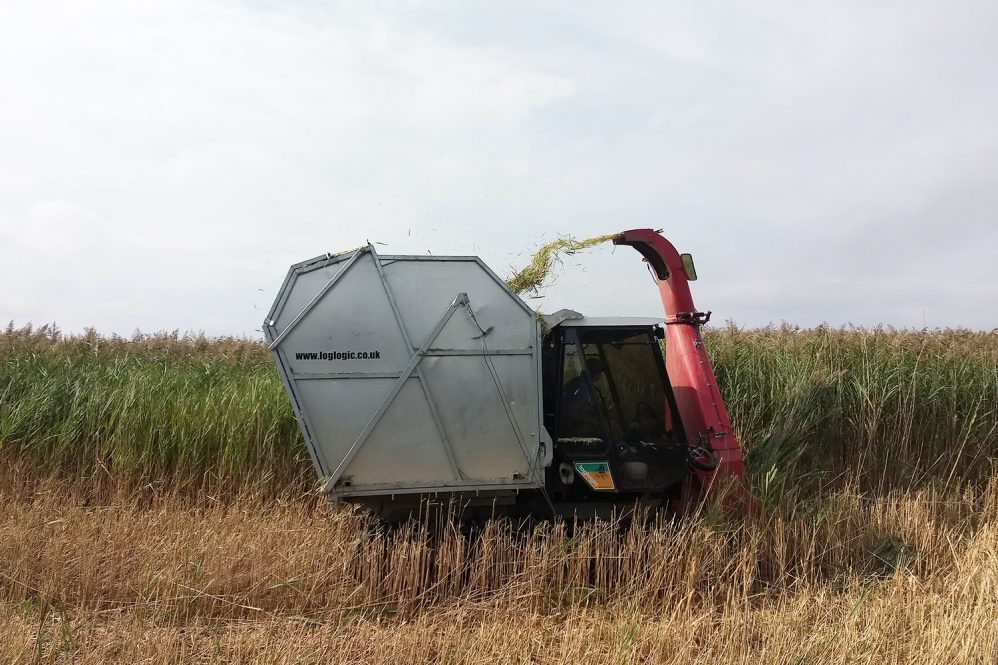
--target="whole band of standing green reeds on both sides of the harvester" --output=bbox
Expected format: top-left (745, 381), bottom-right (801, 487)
top-left (0, 326), bottom-right (998, 496)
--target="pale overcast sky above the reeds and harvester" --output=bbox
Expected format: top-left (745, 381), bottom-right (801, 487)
top-left (0, 0), bottom-right (998, 335)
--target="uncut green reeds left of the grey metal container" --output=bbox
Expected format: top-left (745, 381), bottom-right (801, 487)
top-left (0, 329), bottom-right (305, 486)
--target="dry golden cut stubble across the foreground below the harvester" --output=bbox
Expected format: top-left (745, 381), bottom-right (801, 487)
top-left (0, 464), bottom-right (998, 663)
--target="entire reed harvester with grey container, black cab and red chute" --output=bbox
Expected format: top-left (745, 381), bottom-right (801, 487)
top-left (263, 229), bottom-right (750, 521)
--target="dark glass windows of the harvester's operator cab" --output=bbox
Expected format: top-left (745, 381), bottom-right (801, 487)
top-left (560, 330), bottom-right (672, 442)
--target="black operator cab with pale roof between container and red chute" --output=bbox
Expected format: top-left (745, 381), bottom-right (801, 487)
top-left (542, 313), bottom-right (711, 502)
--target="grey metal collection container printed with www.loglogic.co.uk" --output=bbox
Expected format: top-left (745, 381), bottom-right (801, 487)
top-left (263, 245), bottom-right (552, 499)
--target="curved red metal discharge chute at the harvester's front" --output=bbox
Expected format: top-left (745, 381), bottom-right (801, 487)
top-left (613, 229), bottom-right (755, 509)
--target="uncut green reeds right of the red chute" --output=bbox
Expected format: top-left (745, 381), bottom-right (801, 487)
top-left (705, 326), bottom-right (998, 498)
